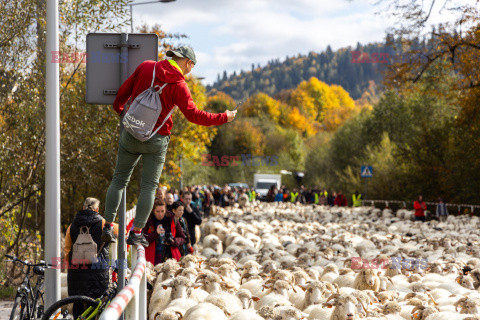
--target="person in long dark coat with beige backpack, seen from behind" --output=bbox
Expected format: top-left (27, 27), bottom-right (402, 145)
top-left (64, 198), bottom-right (118, 315)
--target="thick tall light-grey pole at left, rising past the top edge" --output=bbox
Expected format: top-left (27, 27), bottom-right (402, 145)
top-left (45, 0), bottom-right (63, 308)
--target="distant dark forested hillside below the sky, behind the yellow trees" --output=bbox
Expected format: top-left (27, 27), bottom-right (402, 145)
top-left (207, 37), bottom-right (412, 99)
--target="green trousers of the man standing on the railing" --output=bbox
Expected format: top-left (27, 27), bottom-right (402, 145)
top-left (105, 130), bottom-right (170, 228)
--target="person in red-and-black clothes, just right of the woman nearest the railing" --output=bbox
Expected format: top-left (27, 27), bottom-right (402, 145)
top-left (162, 201), bottom-right (186, 261)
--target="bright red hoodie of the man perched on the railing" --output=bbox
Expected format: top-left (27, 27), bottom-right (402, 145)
top-left (113, 60), bottom-right (227, 136)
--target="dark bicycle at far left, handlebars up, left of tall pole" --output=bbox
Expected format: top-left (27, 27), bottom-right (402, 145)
top-left (5, 254), bottom-right (49, 320)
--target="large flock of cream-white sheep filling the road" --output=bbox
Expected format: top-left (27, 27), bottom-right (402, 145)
top-left (143, 203), bottom-right (480, 320)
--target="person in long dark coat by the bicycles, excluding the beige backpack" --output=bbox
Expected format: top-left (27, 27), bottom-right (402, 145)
top-left (64, 198), bottom-right (118, 318)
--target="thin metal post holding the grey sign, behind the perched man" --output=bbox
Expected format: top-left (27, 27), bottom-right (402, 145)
top-left (117, 33), bottom-right (128, 320)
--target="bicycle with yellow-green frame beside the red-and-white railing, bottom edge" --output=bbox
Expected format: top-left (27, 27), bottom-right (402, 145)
top-left (41, 270), bottom-right (127, 320)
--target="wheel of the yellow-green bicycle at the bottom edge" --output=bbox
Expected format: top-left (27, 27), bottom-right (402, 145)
top-left (42, 296), bottom-right (100, 320)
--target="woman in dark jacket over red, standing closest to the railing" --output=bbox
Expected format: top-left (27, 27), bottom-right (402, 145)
top-left (142, 200), bottom-right (167, 266)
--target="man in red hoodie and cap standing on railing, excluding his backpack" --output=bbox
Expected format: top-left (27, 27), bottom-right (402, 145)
top-left (102, 46), bottom-right (236, 247)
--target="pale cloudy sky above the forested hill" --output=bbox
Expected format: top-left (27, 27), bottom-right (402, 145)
top-left (129, 0), bottom-right (456, 84)
